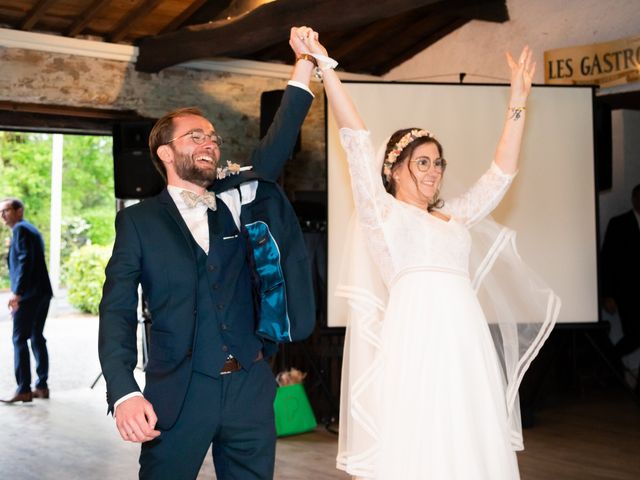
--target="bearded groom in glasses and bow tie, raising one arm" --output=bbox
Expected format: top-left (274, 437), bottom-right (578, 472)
top-left (99, 27), bottom-right (314, 480)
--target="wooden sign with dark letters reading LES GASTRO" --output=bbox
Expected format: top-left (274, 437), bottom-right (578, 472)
top-left (544, 36), bottom-right (640, 87)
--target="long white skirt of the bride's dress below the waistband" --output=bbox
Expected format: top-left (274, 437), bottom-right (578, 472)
top-left (375, 270), bottom-right (519, 480)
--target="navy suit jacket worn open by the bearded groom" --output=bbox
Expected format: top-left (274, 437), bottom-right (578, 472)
top-left (98, 86), bottom-right (315, 418)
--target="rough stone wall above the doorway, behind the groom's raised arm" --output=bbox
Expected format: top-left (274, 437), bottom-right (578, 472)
top-left (0, 47), bottom-right (326, 192)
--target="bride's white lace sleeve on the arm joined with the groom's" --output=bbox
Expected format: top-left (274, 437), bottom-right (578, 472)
top-left (340, 128), bottom-right (394, 284)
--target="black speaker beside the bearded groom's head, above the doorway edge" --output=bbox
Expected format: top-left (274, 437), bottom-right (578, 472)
top-left (113, 121), bottom-right (166, 199)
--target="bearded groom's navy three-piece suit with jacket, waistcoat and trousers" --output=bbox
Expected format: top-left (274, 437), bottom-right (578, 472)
top-left (99, 87), bottom-right (315, 480)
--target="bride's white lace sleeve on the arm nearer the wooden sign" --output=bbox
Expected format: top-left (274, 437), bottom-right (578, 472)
top-left (442, 163), bottom-right (516, 227)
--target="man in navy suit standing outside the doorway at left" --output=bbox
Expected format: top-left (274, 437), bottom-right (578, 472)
top-left (0, 198), bottom-right (53, 403)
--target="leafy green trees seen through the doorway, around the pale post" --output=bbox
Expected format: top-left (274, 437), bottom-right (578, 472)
top-left (0, 132), bottom-right (116, 288)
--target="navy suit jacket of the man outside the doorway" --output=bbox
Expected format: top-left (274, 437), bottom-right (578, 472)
top-left (7, 220), bottom-right (53, 301)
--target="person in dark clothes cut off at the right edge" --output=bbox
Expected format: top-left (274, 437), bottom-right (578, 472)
top-left (602, 185), bottom-right (640, 376)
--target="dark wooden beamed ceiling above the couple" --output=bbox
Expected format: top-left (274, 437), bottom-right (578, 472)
top-left (0, 0), bottom-right (509, 75)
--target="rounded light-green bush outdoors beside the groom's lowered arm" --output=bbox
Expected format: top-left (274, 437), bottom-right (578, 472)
top-left (66, 245), bottom-right (111, 315)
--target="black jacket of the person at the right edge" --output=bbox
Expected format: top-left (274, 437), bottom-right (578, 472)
top-left (601, 210), bottom-right (640, 301)
